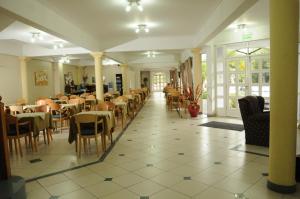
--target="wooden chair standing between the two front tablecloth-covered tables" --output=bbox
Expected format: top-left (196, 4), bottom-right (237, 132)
top-left (49, 103), bottom-right (70, 133)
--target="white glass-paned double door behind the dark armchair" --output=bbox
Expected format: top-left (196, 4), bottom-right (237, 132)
top-left (225, 55), bottom-right (270, 117)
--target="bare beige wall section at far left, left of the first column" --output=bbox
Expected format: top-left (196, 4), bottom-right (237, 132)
top-left (0, 54), bottom-right (22, 104)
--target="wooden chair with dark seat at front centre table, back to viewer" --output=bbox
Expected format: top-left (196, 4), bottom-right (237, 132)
top-left (75, 114), bottom-right (106, 158)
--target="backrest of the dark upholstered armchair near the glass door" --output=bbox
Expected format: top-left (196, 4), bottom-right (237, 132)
top-left (238, 96), bottom-right (265, 121)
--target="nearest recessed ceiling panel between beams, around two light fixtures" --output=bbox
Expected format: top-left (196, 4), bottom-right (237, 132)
top-left (38, 0), bottom-right (221, 38)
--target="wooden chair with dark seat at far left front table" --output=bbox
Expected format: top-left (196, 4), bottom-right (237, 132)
top-left (6, 114), bottom-right (36, 157)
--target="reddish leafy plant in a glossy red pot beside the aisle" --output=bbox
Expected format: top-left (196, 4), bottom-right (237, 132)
top-left (185, 85), bottom-right (202, 117)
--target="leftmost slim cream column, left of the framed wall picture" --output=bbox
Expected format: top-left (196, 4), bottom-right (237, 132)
top-left (19, 57), bottom-right (30, 103)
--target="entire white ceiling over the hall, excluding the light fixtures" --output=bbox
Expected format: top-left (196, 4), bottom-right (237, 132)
top-left (0, 0), bottom-right (274, 68)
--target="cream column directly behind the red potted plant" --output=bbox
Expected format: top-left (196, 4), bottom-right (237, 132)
top-left (192, 48), bottom-right (202, 106)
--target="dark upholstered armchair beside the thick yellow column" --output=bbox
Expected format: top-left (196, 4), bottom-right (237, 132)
top-left (239, 96), bottom-right (270, 146)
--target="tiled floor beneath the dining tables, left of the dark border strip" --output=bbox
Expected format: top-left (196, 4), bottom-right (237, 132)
top-left (10, 111), bottom-right (130, 179)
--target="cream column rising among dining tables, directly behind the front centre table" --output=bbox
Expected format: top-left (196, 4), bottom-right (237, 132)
top-left (91, 52), bottom-right (104, 101)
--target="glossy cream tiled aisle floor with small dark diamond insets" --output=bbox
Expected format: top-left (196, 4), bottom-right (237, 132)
top-left (26, 93), bottom-right (300, 199)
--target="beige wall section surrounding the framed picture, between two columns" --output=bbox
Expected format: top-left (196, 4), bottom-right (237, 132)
top-left (27, 59), bottom-right (54, 103)
